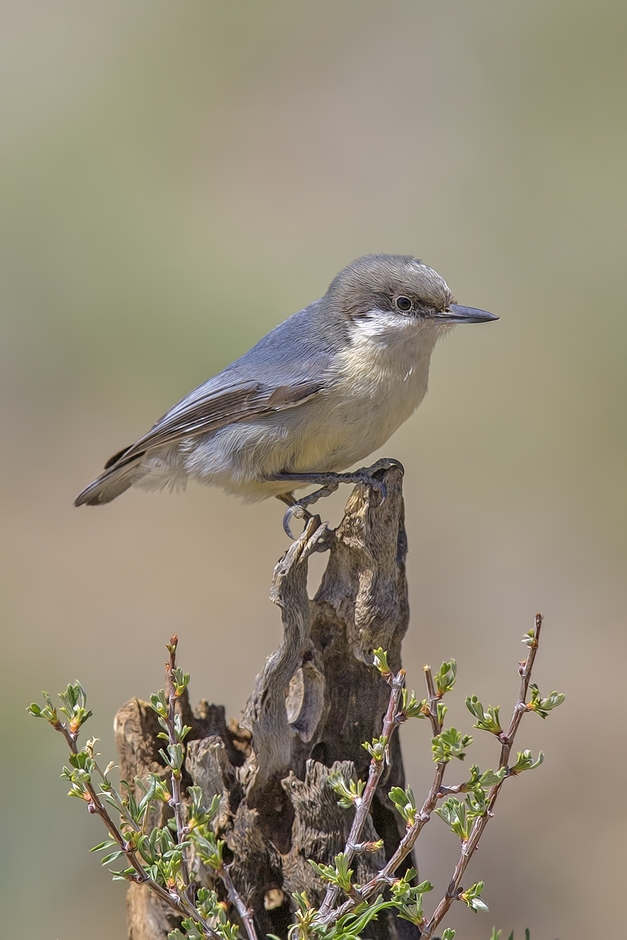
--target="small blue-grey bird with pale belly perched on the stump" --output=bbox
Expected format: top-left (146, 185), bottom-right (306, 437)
top-left (74, 254), bottom-right (498, 536)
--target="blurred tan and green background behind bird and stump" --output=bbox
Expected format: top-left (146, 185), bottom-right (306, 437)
top-left (0, 0), bottom-right (627, 940)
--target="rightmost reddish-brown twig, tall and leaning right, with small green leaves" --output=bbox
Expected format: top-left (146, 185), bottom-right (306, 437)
top-left (420, 614), bottom-right (543, 940)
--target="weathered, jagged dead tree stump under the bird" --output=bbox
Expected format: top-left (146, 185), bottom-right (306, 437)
top-left (115, 469), bottom-right (419, 940)
